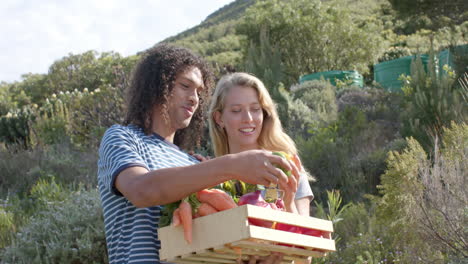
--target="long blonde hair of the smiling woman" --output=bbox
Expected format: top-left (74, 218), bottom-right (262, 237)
top-left (208, 72), bottom-right (297, 157)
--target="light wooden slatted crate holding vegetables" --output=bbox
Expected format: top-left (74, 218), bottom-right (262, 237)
top-left (159, 205), bottom-right (335, 264)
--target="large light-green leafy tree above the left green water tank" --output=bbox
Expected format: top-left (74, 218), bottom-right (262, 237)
top-left (238, 0), bottom-right (381, 86)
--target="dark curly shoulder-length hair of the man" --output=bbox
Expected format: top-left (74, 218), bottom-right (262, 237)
top-left (124, 44), bottom-right (214, 149)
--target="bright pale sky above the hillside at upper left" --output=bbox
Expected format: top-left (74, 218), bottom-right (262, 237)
top-left (0, 0), bottom-right (234, 82)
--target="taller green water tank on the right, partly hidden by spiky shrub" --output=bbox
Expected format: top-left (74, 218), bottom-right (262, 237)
top-left (374, 55), bottom-right (429, 92)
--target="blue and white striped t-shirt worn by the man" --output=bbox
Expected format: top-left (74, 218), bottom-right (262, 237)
top-left (98, 125), bottom-right (198, 263)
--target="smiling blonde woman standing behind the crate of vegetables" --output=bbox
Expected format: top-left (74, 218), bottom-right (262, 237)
top-left (209, 72), bottom-right (313, 216)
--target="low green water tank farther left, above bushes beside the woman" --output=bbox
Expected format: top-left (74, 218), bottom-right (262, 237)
top-left (299, 71), bottom-right (364, 87)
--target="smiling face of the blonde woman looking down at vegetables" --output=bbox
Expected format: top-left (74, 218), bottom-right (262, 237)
top-left (215, 86), bottom-right (263, 153)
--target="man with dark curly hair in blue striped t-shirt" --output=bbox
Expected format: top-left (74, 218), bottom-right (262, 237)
top-left (98, 44), bottom-right (298, 263)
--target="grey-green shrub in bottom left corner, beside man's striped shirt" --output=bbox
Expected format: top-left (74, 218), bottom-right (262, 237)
top-left (1, 190), bottom-right (108, 263)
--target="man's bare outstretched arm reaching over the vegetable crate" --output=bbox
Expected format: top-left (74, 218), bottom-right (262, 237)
top-left (115, 150), bottom-right (298, 207)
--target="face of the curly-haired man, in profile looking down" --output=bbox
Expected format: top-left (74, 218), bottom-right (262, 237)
top-left (153, 67), bottom-right (204, 138)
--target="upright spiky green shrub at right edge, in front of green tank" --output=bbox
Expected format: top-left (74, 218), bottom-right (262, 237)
top-left (402, 53), bottom-right (468, 151)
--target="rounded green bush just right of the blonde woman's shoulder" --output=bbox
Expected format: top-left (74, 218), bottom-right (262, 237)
top-left (295, 106), bottom-right (395, 201)
